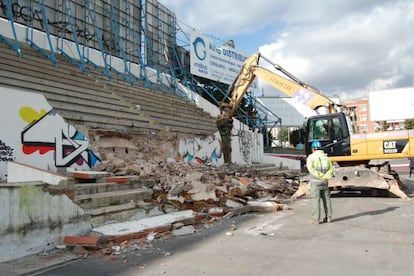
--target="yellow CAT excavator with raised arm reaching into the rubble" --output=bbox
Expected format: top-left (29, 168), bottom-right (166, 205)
top-left (217, 53), bottom-right (414, 200)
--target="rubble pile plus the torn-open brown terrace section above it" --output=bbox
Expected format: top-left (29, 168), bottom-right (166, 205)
top-left (89, 130), bottom-right (300, 213)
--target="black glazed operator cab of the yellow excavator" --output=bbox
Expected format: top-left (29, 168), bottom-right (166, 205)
top-left (305, 112), bottom-right (352, 160)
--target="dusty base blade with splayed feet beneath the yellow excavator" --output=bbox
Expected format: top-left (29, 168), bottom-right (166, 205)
top-left (292, 167), bottom-right (410, 200)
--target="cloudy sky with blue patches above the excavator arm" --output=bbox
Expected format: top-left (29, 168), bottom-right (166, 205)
top-left (160, 0), bottom-right (414, 101)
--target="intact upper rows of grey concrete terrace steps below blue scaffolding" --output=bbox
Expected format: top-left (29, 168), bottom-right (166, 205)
top-left (0, 43), bottom-right (216, 136)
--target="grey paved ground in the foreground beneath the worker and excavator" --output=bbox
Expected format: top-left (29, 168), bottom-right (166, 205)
top-left (0, 177), bottom-right (414, 276)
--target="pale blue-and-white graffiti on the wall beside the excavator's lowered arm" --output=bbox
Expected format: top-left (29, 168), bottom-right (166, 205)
top-left (178, 135), bottom-right (222, 164)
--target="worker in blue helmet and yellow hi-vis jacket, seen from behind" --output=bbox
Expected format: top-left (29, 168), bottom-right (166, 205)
top-left (306, 141), bottom-right (334, 224)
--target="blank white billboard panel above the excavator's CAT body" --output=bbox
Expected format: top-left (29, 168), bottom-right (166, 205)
top-left (369, 87), bottom-right (414, 121)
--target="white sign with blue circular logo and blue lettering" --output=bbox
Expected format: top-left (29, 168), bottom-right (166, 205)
top-left (190, 31), bottom-right (257, 88)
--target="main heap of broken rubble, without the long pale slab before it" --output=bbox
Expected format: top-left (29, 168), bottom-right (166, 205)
top-left (97, 158), bottom-right (300, 216)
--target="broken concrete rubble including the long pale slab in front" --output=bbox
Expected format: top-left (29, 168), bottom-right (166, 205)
top-left (59, 158), bottom-right (300, 259)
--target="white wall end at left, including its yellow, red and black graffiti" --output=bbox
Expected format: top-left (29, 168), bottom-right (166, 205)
top-left (0, 86), bottom-right (100, 179)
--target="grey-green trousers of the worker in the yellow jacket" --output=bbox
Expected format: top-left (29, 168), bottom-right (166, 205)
top-left (311, 184), bottom-right (332, 221)
